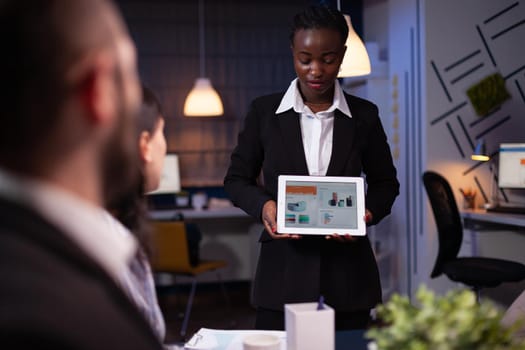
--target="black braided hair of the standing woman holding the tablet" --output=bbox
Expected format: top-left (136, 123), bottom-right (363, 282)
top-left (290, 5), bottom-right (348, 45)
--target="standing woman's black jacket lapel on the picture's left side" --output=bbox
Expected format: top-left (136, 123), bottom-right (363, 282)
top-left (277, 109), bottom-right (308, 175)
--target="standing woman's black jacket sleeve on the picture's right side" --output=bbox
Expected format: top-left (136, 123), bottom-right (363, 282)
top-left (362, 105), bottom-right (399, 225)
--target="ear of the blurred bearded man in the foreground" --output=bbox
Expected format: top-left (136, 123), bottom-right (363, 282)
top-left (79, 53), bottom-right (117, 124)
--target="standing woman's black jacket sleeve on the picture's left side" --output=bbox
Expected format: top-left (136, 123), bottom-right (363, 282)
top-left (224, 102), bottom-right (273, 220)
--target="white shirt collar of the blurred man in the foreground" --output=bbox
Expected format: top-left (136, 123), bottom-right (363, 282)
top-left (0, 169), bottom-right (137, 283)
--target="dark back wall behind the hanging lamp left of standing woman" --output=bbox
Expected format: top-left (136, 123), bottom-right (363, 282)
top-left (118, 0), bottom-right (310, 186)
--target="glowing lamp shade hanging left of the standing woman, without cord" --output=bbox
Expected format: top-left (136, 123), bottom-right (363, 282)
top-left (184, 78), bottom-right (224, 117)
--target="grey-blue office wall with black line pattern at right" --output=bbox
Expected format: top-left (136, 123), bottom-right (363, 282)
top-left (389, 0), bottom-right (525, 298)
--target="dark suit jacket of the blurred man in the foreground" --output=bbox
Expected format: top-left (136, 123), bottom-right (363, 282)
top-left (0, 199), bottom-right (162, 350)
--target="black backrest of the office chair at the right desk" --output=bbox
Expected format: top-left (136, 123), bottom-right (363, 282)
top-left (423, 171), bottom-right (463, 278)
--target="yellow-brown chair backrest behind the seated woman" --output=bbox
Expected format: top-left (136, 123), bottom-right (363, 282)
top-left (151, 221), bottom-right (192, 274)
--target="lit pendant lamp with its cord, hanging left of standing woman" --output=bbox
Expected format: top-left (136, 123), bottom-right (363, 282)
top-left (184, 0), bottom-right (224, 117)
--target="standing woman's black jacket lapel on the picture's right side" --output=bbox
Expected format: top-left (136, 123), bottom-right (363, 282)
top-left (326, 109), bottom-right (356, 176)
